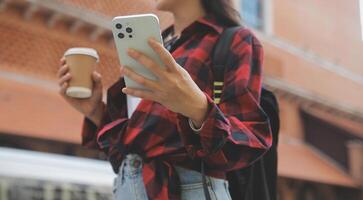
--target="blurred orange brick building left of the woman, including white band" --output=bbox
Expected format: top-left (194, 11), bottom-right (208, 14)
top-left (0, 0), bottom-right (171, 200)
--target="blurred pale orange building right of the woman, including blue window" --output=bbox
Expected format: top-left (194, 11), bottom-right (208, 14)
top-left (237, 0), bottom-right (363, 200)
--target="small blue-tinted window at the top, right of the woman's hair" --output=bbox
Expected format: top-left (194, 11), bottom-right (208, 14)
top-left (241, 0), bottom-right (263, 30)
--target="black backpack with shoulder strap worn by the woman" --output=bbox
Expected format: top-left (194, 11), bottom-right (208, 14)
top-left (206, 27), bottom-right (280, 200)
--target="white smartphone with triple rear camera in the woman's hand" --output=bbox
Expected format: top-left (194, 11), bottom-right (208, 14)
top-left (112, 14), bottom-right (163, 89)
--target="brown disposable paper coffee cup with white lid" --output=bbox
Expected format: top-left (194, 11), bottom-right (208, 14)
top-left (64, 47), bottom-right (99, 98)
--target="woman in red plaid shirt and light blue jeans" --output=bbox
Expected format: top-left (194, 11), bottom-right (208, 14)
top-left (58, 0), bottom-right (271, 200)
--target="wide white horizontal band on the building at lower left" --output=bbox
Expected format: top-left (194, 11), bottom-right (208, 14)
top-left (0, 147), bottom-right (116, 187)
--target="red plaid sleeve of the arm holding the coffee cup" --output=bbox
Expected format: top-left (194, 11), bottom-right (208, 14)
top-left (81, 78), bottom-right (127, 149)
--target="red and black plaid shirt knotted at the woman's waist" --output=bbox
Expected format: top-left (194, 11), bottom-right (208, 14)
top-left (82, 16), bottom-right (272, 199)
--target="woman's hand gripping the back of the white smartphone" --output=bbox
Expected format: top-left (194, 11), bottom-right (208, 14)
top-left (121, 39), bottom-right (208, 127)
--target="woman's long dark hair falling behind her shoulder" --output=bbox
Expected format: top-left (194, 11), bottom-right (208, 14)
top-left (202, 0), bottom-right (241, 27)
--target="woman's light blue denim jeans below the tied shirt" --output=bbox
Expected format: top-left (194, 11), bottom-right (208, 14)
top-left (113, 154), bottom-right (231, 200)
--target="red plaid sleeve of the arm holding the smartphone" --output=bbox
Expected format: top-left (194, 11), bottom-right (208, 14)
top-left (177, 29), bottom-right (272, 171)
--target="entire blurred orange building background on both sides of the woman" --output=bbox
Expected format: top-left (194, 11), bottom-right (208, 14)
top-left (0, 0), bottom-right (363, 200)
